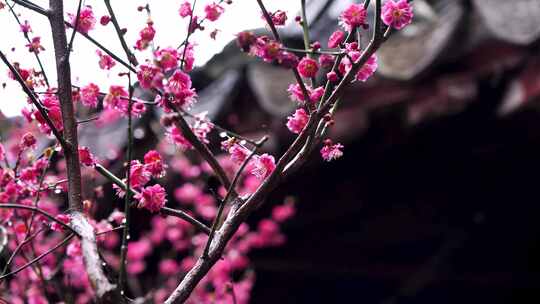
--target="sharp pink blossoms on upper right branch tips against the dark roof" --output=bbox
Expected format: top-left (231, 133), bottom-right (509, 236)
top-left (236, 0), bottom-right (413, 161)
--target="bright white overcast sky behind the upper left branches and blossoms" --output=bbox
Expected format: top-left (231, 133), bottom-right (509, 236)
top-left (0, 0), bottom-right (300, 116)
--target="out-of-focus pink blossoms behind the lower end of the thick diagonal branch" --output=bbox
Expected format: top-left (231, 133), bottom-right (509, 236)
top-left (127, 147), bottom-right (295, 303)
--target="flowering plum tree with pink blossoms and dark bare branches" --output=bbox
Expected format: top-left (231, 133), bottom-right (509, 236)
top-left (0, 0), bottom-right (413, 303)
